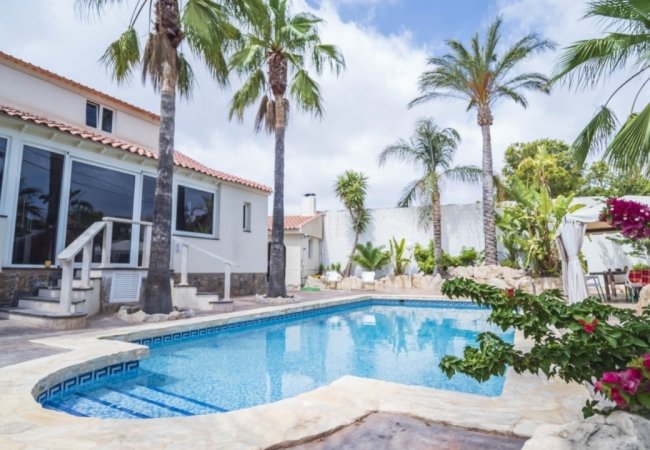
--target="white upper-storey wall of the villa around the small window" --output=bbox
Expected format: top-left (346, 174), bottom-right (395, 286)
top-left (0, 62), bottom-right (158, 149)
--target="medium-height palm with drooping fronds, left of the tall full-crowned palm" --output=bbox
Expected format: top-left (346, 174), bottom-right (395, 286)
top-left (379, 119), bottom-right (481, 273)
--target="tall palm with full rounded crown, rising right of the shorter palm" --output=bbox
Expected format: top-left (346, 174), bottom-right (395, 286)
top-left (409, 17), bottom-right (554, 264)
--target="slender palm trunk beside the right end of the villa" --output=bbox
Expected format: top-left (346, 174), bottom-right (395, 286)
top-left (267, 95), bottom-right (287, 297)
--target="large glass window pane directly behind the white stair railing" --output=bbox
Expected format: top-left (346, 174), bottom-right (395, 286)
top-left (66, 161), bottom-right (135, 263)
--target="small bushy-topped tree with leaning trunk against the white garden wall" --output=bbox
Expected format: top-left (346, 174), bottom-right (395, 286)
top-left (334, 170), bottom-right (370, 277)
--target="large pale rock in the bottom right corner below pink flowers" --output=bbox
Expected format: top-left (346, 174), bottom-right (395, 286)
top-left (523, 411), bottom-right (650, 450)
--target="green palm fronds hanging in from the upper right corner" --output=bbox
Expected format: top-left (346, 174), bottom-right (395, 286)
top-left (553, 0), bottom-right (650, 173)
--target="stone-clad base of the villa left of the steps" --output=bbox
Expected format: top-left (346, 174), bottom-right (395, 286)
top-left (0, 269), bottom-right (61, 304)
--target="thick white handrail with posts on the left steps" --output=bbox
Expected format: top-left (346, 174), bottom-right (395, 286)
top-left (58, 217), bottom-right (152, 313)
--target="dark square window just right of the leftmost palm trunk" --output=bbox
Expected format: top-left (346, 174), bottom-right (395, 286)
top-left (176, 185), bottom-right (214, 235)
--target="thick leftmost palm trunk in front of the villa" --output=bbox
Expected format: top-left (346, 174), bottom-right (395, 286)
top-left (142, 63), bottom-right (176, 314)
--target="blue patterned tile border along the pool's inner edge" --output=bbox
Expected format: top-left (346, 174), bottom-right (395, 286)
top-left (36, 298), bottom-right (480, 404)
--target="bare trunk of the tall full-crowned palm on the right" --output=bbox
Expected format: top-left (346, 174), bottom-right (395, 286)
top-left (478, 107), bottom-right (498, 264)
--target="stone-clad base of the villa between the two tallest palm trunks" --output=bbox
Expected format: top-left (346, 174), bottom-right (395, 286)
top-left (173, 273), bottom-right (266, 298)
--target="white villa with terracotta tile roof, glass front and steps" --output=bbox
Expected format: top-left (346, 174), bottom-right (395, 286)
top-left (0, 52), bottom-right (271, 326)
